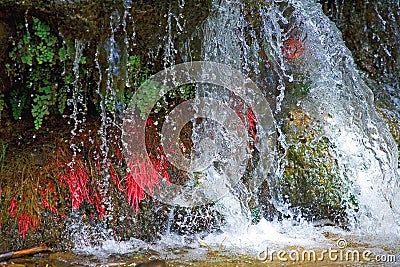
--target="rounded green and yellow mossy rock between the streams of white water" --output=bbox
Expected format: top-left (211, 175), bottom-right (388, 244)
top-left (279, 109), bottom-right (354, 225)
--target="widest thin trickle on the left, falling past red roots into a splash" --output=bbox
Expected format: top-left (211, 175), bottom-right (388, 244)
top-left (68, 1), bottom-right (131, 250)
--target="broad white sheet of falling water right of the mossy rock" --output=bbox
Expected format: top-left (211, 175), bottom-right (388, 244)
top-left (293, 1), bottom-right (400, 235)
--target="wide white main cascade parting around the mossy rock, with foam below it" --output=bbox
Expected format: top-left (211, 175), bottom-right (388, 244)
top-left (148, 1), bottom-right (400, 258)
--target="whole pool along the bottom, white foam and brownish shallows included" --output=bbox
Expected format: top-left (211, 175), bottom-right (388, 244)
top-left (0, 222), bottom-right (400, 267)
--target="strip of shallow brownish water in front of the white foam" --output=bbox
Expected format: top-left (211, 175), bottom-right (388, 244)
top-left (0, 247), bottom-right (399, 267)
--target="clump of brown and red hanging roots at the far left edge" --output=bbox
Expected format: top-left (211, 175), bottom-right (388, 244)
top-left (0, 144), bottom-right (66, 243)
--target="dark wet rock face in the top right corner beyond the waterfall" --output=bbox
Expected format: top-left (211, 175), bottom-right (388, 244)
top-left (318, 0), bottom-right (400, 90)
